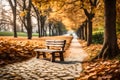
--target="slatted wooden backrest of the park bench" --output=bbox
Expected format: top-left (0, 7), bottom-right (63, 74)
top-left (46, 40), bottom-right (66, 51)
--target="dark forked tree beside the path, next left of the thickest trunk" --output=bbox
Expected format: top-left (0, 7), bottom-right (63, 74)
top-left (81, 0), bottom-right (98, 46)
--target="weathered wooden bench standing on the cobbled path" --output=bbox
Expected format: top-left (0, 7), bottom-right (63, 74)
top-left (34, 40), bottom-right (66, 62)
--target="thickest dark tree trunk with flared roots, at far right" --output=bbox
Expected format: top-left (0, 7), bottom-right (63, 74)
top-left (99, 0), bottom-right (119, 59)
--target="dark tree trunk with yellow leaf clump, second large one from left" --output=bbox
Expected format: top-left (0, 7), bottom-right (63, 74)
top-left (20, 0), bottom-right (32, 39)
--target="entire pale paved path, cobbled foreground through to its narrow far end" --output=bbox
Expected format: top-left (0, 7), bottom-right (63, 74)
top-left (0, 39), bottom-right (87, 80)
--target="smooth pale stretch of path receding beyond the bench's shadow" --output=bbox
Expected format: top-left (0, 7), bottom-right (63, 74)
top-left (66, 38), bottom-right (87, 62)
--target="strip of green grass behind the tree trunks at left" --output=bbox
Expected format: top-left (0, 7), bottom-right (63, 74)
top-left (0, 32), bottom-right (38, 37)
